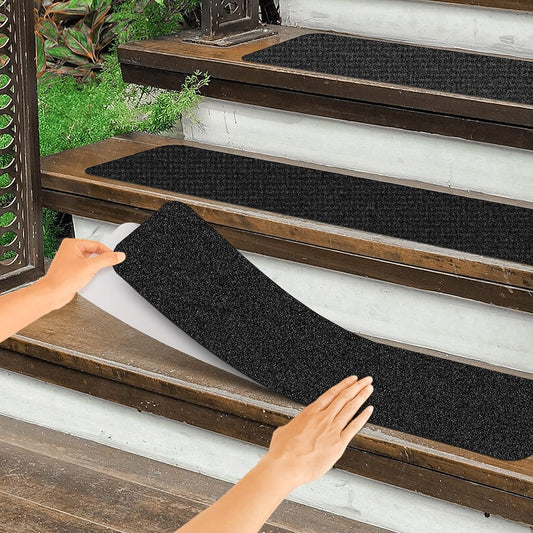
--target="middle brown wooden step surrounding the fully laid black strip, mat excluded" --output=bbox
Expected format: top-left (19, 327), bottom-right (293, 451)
top-left (41, 134), bottom-right (533, 312)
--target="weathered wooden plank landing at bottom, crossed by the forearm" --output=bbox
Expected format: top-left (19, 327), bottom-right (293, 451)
top-left (0, 417), bottom-right (386, 533)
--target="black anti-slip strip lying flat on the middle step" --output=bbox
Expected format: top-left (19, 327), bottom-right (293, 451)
top-left (87, 145), bottom-right (533, 264)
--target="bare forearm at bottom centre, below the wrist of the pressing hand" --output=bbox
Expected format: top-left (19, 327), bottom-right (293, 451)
top-left (176, 454), bottom-right (298, 533)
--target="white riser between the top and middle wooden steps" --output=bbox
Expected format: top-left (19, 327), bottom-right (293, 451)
top-left (183, 96), bottom-right (533, 202)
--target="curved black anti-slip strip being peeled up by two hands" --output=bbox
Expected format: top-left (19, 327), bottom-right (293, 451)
top-left (114, 202), bottom-right (533, 460)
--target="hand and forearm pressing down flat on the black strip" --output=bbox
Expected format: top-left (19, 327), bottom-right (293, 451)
top-left (176, 376), bottom-right (373, 533)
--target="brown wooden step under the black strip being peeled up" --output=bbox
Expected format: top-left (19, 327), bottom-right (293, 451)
top-left (3, 297), bottom-right (533, 498)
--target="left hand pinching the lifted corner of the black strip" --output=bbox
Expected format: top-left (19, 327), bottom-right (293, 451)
top-left (37, 239), bottom-right (126, 309)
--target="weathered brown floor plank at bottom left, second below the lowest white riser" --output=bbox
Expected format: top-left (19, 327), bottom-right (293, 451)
top-left (0, 443), bottom-right (203, 533)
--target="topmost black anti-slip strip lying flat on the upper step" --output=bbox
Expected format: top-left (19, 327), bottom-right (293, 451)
top-left (243, 33), bottom-right (533, 104)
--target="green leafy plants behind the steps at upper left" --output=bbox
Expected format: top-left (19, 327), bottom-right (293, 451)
top-left (36, 0), bottom-right (205, 257)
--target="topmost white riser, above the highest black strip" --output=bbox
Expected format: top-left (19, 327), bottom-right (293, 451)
top-left (280, 0), bottom-right (533, 59)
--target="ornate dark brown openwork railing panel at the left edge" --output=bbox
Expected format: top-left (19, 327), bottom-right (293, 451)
top-left (0, 0), bottom-right (43, 290)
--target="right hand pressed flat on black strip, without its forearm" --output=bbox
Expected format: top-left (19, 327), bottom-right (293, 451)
top-left (262, 376), bottom-right (374, 487)
